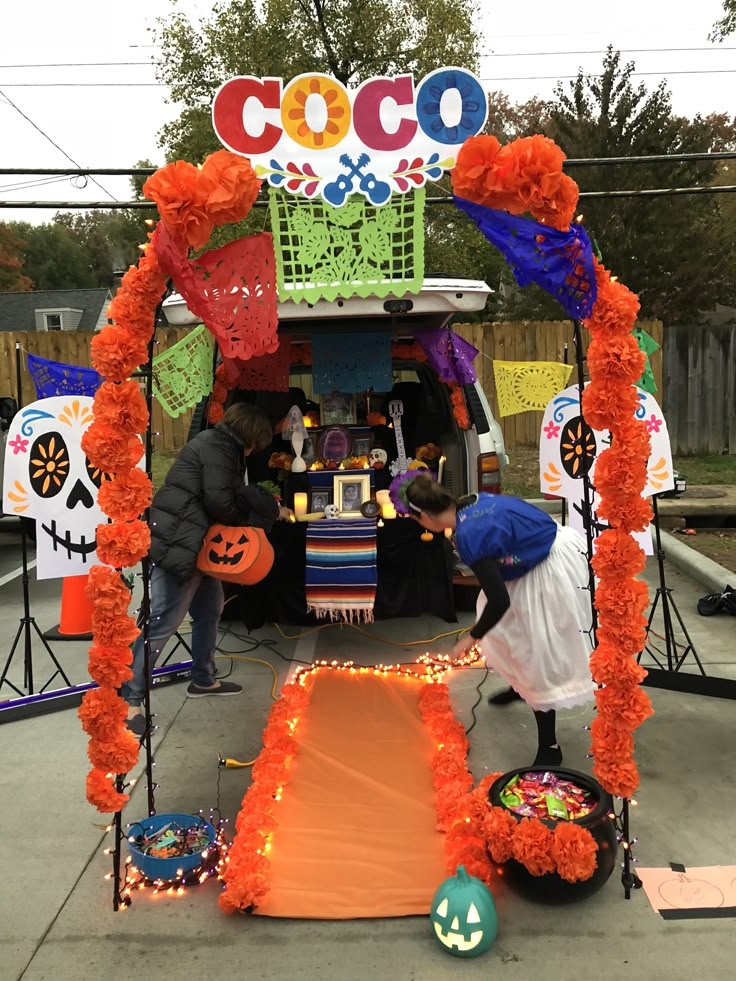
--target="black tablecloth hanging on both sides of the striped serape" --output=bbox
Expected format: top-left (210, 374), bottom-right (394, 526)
top-left (223, 518), bottom-right (457, 630)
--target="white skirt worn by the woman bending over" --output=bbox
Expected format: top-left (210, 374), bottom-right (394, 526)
top-left (478, 527), bottom-right (595, 712)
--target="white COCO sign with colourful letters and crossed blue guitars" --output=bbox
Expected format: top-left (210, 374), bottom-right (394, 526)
top-left (212, 68), bottom-right (488, 208)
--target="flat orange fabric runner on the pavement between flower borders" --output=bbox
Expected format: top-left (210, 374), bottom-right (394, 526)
top-left (254, 671), bottom-right (446, 919)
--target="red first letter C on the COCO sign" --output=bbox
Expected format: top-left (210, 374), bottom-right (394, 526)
top-left (212, 76), bottom-right (281, 156)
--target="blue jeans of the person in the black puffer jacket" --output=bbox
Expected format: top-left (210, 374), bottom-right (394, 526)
top-left (120, 566), bottom-right (225, 707)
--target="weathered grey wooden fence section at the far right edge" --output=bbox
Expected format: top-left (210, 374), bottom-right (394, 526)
top-left (663, 324), bottom-right (736, 454)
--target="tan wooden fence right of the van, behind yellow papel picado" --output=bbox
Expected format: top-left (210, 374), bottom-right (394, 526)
top-left (453, 320), bottom-right (666, 450)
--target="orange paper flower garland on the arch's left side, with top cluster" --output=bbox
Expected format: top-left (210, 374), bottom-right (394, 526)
top-left (79, 150), bottom-right (260, 813)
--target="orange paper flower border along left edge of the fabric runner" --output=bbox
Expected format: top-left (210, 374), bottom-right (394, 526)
top-left (219, 675), bottom-right (310, 913)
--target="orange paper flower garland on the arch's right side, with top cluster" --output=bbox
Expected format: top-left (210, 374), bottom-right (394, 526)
top-left (452, 136), bottom-right (652, 804)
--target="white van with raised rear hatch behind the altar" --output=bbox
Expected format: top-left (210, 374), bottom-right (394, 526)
top-left (163, 278), bottom-right (507, 496)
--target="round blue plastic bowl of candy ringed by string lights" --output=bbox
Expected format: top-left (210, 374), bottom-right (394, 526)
top-left (127, 814), bottom-right (217, 882)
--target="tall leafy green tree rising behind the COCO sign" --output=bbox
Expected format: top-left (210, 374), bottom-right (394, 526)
top-left (155, 0), bottom-right (478, 162)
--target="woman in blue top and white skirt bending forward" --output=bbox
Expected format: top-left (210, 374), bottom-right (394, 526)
top-left (392, 472), bottom-right (594, 766)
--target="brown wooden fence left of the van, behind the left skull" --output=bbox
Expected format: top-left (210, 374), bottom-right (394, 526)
top-left (0, 327), bottom-right (197, 451)
